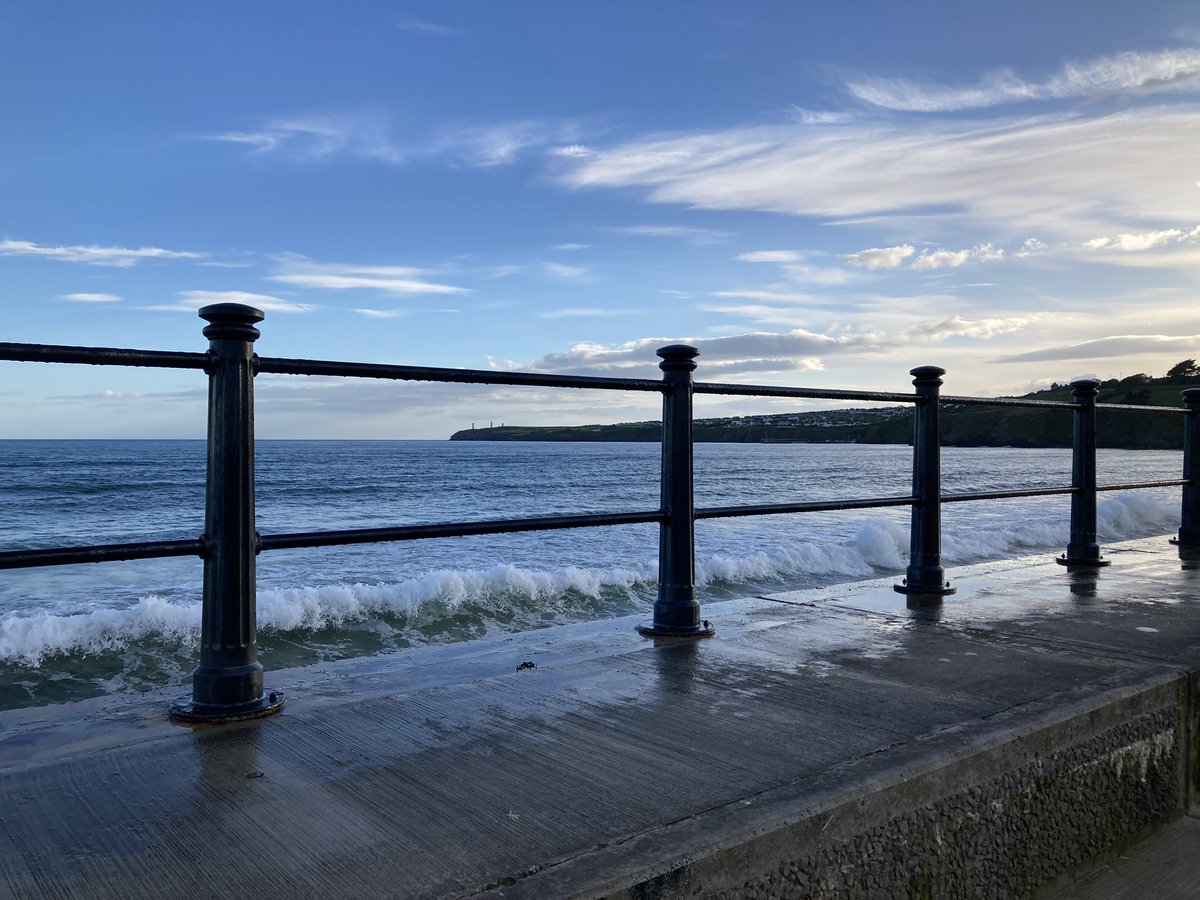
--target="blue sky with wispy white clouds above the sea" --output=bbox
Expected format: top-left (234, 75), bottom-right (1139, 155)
top-left (0, 0), bottom-right (1200, 438)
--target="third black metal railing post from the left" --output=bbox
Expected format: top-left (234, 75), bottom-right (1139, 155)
top-left (893, 366), bottom-right (955, 598)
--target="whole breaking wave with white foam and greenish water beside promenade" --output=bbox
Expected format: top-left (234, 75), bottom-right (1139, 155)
top-left (0, 492), bottom-right (1178, 668)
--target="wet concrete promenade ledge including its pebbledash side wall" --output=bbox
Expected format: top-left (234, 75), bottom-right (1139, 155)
top-left (0, 538), bottom-right (1200, 900)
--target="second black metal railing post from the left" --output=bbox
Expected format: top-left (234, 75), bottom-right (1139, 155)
top-left (637, 344), bottom-right (714, 637)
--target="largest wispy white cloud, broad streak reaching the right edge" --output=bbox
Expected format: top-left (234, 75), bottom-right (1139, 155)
top-left (558, 106), bottom-right (1200, 243)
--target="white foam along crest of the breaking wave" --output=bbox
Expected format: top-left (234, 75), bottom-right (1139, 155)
top-left (0, 492), bottom-right (1178, 666)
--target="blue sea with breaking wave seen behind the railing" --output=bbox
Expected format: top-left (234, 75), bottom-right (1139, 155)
top-left (0, 440), bottom-right (1182, 709)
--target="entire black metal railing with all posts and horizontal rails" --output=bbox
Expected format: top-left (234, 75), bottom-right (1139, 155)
top-left (0, 304), bottom-right (1200, 722)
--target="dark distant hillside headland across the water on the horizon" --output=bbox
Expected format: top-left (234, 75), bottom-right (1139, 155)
top-left (450, 360), bottom-right (1200, 450)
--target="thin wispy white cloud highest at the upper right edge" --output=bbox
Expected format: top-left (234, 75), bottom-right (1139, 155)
top-left (846, 48), bottom-right (1200, 113)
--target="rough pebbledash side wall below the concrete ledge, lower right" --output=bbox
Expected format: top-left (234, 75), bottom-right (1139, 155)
top-left (618, 677), bottom-right (1196, 900)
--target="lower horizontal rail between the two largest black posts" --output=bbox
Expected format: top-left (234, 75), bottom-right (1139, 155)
top-left (260, 510), bottom-right (667, 551)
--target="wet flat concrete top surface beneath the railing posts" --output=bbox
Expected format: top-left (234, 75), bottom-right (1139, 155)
top-left (0, 539), bottom-right (1200, 898)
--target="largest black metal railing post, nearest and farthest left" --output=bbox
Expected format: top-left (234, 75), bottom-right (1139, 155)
top-left (170, 304), bottom-right (283, 722)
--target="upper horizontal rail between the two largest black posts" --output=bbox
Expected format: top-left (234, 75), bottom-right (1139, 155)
top-left (257, 356), bottom-right (665, 394)
